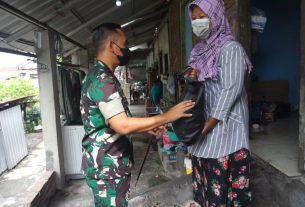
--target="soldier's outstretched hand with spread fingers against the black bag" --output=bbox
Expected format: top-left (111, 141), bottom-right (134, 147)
top-left (163, 101), bottom-right (195, 123)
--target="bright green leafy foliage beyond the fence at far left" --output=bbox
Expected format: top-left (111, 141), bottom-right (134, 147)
top-left (0, 78), bottom-right (38, 101)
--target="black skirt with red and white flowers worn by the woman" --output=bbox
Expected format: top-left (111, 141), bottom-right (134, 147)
top-left (192, 149), bottom-right (251, 207)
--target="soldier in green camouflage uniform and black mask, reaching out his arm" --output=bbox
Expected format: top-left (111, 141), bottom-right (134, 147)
top-left (81, 23), bottom-right (193, 207)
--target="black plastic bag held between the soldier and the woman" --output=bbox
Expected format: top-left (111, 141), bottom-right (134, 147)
top-left (172, 79), bottom-right (205, 146)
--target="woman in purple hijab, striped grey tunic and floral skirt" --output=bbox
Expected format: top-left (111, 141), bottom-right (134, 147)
top-left (189, 0), bottom-right (252, 207)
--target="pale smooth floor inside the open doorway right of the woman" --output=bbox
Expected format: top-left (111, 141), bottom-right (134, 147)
top-left (250, 117), bottom-right (301, 177)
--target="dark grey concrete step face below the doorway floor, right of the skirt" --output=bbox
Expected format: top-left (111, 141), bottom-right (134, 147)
top-left (251, 154), bottom-right (305, 207)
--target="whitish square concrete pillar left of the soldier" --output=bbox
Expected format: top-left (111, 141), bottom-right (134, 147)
top-left (36, 30), bottom-right (65, 189)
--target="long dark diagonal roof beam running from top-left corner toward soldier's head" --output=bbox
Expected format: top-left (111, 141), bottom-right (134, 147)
top-left (0, 0), bottom-right (86, 49)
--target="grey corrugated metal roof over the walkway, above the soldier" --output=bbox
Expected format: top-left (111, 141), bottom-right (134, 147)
top-left (0, 0), bottom-right (169, 53)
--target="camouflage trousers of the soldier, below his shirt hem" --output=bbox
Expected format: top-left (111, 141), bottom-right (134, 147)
top-left (86, 176), bottom-right (131, 207)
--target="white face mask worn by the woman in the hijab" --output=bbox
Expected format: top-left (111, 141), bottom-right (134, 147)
top-left (192, 18), bottom-right (211, 39)
